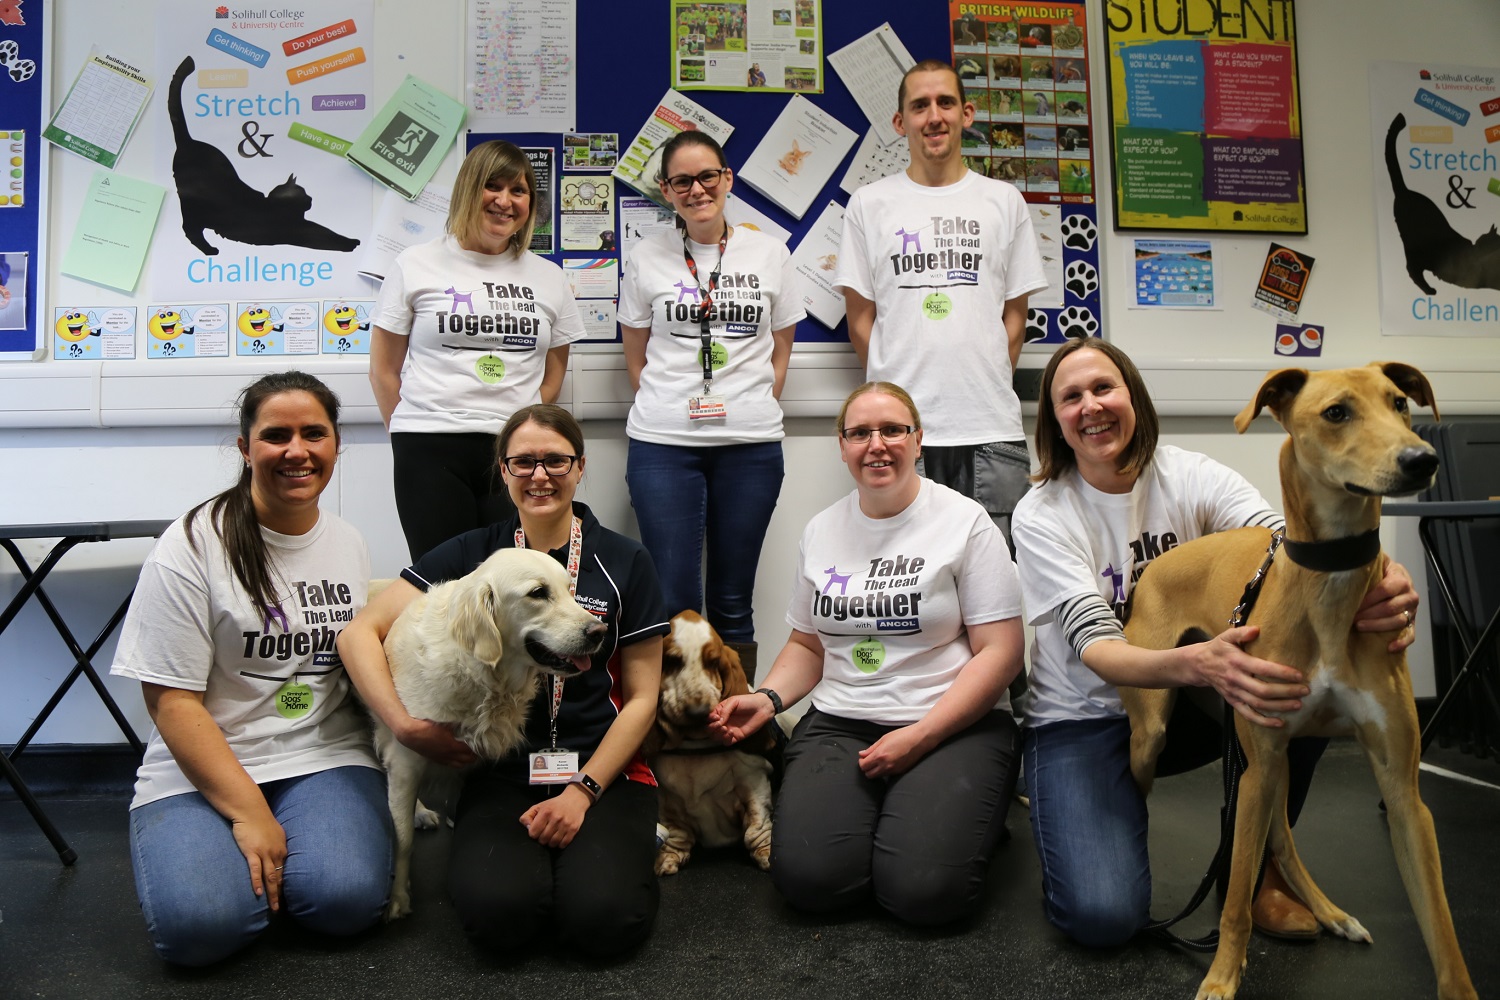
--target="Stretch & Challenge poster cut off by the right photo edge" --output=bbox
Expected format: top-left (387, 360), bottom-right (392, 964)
top-left (1370, 63), bottom-right (1500, 337)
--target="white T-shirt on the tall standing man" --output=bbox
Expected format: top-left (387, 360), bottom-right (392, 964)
top-left (834, 171), bottom-right (1047, 447)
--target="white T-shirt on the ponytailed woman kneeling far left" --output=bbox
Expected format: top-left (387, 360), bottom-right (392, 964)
top-left (110, 508), bottom-right (380, 810)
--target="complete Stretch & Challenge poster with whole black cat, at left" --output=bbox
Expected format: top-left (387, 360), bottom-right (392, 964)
top-left (150, 0), bottom-right (375, 301)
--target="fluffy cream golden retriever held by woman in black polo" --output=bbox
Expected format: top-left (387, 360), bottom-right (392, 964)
top-left (375, 549), bottom-right (606, 921)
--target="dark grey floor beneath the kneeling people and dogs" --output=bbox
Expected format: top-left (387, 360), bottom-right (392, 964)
top-left (0, 742), bottom-right (1500, 1000)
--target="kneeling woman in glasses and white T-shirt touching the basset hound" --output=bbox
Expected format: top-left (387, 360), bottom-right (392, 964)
top-left (710, 382), bottom-right (1022, 924)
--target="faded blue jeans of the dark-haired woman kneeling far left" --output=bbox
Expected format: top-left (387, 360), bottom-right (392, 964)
top-left (131, 766), bottom-right (393, 966)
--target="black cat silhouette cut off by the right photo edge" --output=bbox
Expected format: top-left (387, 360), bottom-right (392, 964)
top-left (1386, 114), bottom-right (1500, 295)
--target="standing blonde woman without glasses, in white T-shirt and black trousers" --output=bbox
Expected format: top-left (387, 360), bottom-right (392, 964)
top-left (371, 139), bottom-right (584, 559)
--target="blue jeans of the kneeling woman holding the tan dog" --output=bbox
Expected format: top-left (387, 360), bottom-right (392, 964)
top-left (1025, 717), bottom-right (1151, 948)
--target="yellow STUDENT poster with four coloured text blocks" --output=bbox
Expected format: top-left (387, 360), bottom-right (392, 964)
top-left (1104, 0), bottom-right (1308, 234)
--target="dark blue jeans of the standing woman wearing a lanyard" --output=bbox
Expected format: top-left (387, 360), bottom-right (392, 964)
top-left (626, 439), bottom-right (785, 642)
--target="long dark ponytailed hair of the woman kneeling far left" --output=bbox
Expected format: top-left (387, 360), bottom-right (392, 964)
top-left (183, 372), bottom-right (339, 616)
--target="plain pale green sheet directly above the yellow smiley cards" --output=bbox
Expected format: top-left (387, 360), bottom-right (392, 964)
top-left (63, 169), bottom-right (167, 292)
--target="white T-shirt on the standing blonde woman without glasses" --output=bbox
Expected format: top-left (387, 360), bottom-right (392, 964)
top-left (375, 235), bottom-right (584, 433)
